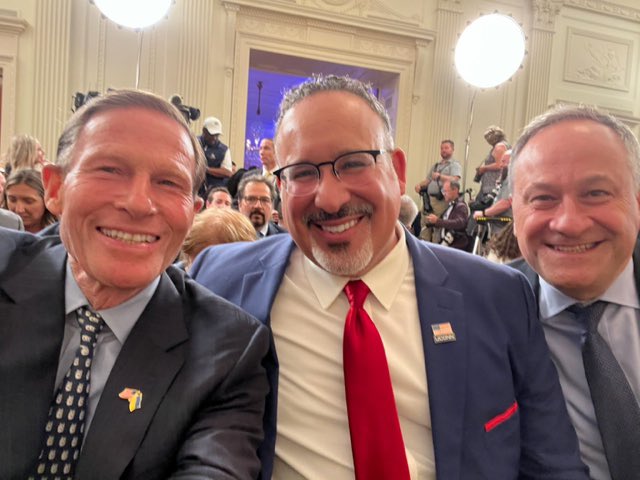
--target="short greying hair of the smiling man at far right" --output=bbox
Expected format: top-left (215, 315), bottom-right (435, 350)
top-left (509, 105), bottom-right (640, 190)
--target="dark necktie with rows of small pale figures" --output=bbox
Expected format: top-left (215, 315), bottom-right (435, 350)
top-left (29, 307), bottom-right (104, 479)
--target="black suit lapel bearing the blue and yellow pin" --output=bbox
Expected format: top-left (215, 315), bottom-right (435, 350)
top-left (77, 273), bottom-right (188, 480)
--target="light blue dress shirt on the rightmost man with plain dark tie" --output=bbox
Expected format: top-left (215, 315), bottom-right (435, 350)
top-left (540, 260), bottom-right (640, 480)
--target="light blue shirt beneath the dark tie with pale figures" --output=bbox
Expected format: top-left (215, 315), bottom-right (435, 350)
top-left (54, 262), bottom-right (160, 438)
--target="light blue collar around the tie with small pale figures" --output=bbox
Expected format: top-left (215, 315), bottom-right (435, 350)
top-left (64, 261), bottom-right (160, 344)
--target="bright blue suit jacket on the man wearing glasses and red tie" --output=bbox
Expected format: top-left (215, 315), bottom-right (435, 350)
top-left (191, 235), bottom-right (588, 480)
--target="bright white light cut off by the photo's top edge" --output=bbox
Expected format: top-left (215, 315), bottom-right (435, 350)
top-left (94, 0), bottom-right (171, 28)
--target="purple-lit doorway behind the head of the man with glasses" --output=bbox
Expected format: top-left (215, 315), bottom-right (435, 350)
top-left (244, 49), bottom-right (399, 168)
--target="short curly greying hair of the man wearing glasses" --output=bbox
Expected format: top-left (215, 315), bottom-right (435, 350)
top-left (276, 74), bottom-right (394, 150)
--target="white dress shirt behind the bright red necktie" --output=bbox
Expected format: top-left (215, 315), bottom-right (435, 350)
top-left (271, 228), bottom-right (435, 480)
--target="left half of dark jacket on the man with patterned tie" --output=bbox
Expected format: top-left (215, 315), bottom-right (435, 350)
top-left (0, 242), bottom-right (65, 478)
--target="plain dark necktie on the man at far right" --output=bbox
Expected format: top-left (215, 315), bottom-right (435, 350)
top-left (569, 301), bottom-right (640, 480)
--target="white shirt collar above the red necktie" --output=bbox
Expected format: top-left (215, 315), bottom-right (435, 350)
top-left (303, 224), bottom-right (410, 310)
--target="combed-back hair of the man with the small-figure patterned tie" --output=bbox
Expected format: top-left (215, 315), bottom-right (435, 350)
top-left (55, 90), bottom-right (206, 196)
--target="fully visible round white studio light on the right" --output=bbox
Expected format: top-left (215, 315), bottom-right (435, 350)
top-left (455, 13), bottom-right (525, 88)
